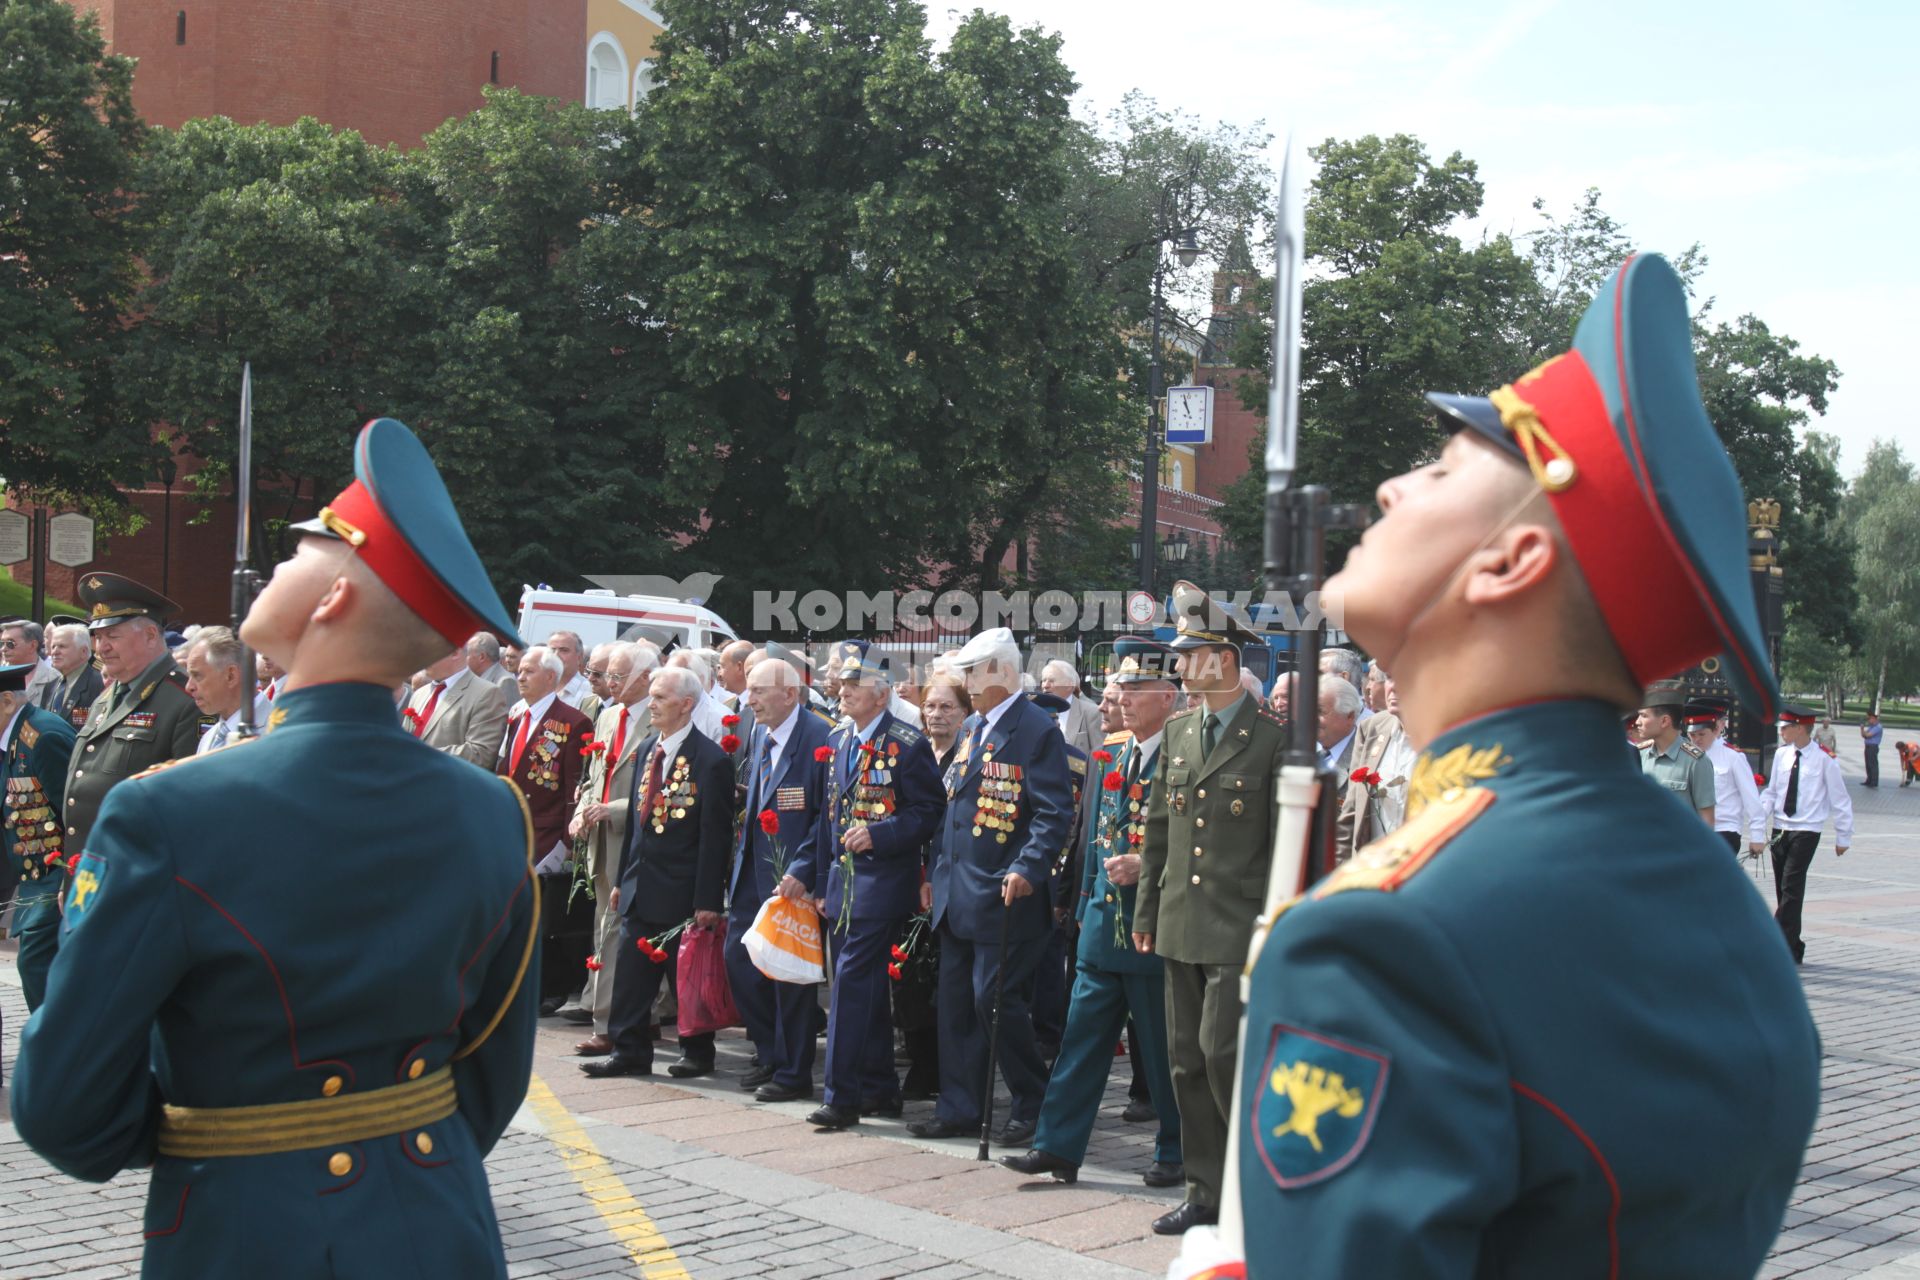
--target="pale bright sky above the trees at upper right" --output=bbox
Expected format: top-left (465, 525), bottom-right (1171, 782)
top-left (927, 0), bottom-right (1920, 476)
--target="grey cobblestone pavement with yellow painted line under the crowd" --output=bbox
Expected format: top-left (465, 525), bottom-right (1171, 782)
top-left (11, 729), bottom-right (1920, 1280)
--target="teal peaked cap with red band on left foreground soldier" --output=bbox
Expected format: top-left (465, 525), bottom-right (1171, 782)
top-left (294, 418), bottom-right (524, 645)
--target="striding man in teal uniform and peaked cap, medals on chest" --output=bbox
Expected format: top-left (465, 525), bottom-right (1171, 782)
top-left (1000, 635), bottom-right (1187, 1186)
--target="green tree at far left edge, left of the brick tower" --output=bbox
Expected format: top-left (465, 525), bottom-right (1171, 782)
top-left (0, 0), bottom-right (157, 516)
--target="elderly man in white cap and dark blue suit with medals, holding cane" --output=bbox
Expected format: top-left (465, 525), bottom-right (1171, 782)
top-left (908, 628), bottom-right (1073, 1146)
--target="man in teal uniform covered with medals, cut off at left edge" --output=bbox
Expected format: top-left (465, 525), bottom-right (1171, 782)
top-left (0, 662), bottom-right (73, 1013)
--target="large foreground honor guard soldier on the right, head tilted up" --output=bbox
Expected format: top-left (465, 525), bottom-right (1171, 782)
top-left (1181, 255), bottom-right (1820, 1280)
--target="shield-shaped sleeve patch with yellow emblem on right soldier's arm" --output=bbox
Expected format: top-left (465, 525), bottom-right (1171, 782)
top-left (1250, 1023), bottom-right (1392, 1190)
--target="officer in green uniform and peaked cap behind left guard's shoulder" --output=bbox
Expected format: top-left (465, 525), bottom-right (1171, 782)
top-left (65, 574), bottom-right (200, 852)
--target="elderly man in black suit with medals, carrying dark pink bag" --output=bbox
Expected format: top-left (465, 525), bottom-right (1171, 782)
top-left (580, 666), bottom-right (733, 1079)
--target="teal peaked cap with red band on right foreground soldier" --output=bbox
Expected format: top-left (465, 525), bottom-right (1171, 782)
top-left (1427, 253), bottom-right (1780, 718)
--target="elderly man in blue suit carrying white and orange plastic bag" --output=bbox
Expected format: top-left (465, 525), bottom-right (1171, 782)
top-left (726, 658), bottom-right (829, 1102)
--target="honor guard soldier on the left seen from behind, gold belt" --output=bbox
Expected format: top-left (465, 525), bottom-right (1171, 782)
top-left (12, 418), bottom-right (538, 1280)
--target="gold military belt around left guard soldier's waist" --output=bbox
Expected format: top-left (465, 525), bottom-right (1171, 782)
top-left (159, 1067), bottom-right (459, 1159)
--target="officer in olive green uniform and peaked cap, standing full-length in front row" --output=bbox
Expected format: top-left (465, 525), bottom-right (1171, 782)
top-left (1133, 581), bottom-right (1286, 1236)
